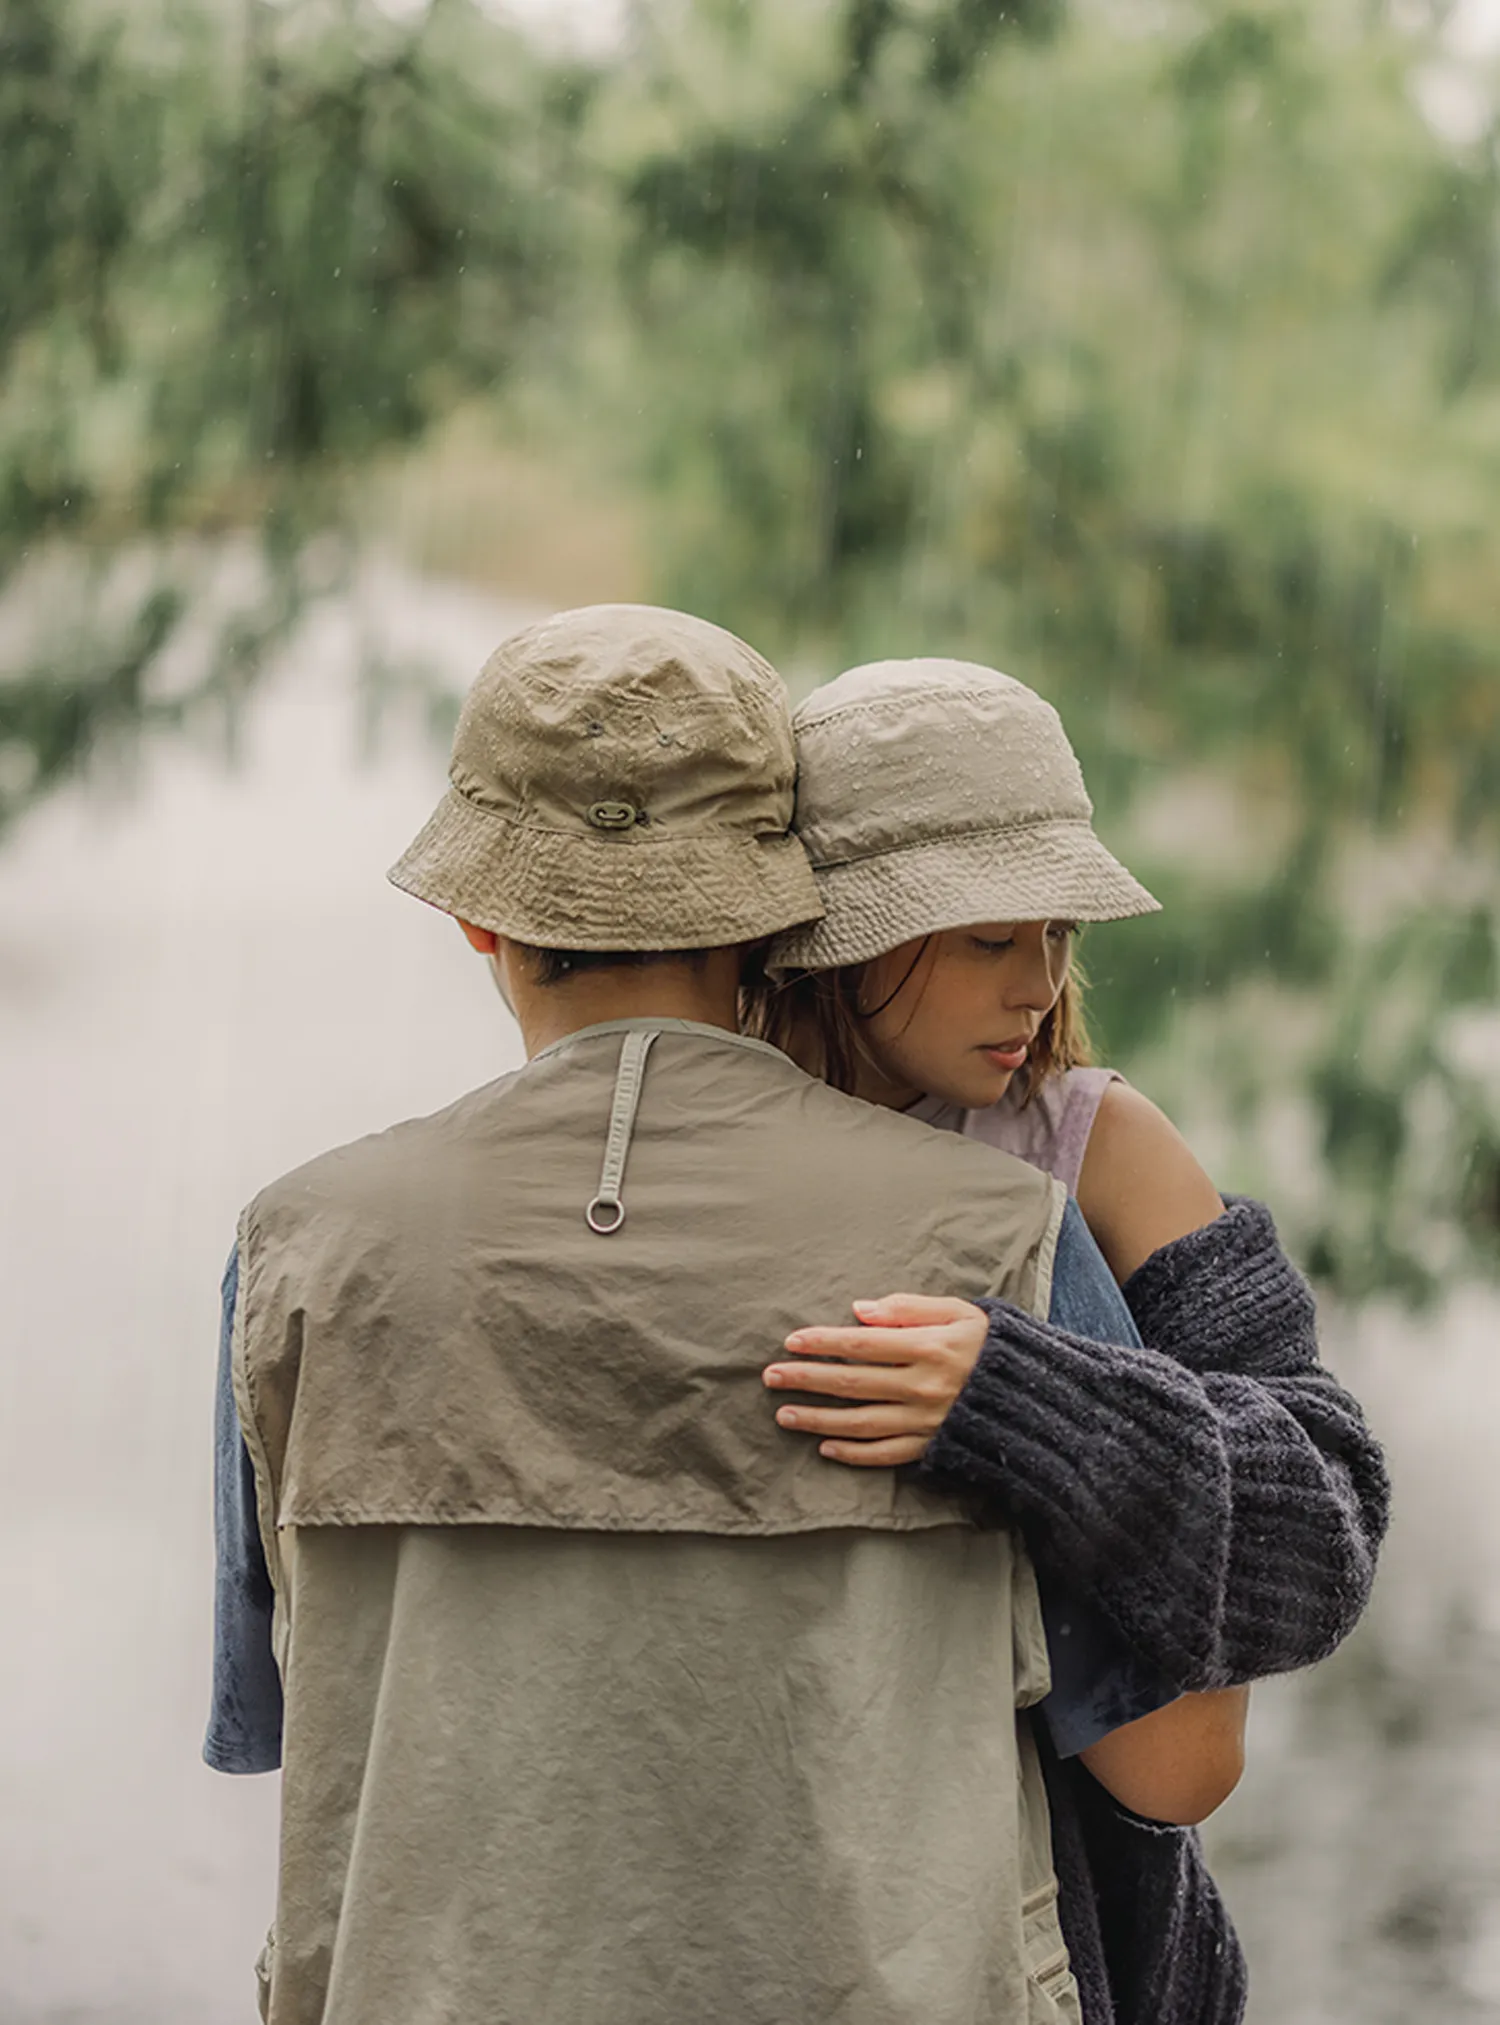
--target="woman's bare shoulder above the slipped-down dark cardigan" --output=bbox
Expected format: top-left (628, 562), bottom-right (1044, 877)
top-left (1079, 1083), bottom-right (1225, 1280)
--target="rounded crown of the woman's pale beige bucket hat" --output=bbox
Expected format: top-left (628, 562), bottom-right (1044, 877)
top-left (794, 658), bottom-right (1093, 867)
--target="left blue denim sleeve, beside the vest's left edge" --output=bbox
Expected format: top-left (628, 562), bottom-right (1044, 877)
top-left (202, 1251), bottom-right (281, 1772)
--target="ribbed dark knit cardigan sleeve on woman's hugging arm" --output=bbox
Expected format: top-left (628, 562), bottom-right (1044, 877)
top-left (919, 1201), bottom-right (1389, 1693)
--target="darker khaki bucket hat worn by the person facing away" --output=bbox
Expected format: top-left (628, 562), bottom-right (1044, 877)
top-left (389, 605), bottom-right (822, 950)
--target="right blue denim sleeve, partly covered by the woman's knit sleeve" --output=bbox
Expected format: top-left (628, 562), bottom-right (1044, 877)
top-left (1040, 1199), bottom-right (1178, 1758)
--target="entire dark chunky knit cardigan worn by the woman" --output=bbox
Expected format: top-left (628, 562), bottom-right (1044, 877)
top-left (917, 1201), bottom-right (1389, 2025)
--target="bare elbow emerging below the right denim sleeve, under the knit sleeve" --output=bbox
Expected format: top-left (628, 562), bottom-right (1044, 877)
top-left (1079, 1687), bottom-right (1249, 1829)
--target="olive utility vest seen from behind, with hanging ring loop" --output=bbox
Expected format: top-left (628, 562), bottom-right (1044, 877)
top-left (235, 1021), bottom-right (1077, 2025)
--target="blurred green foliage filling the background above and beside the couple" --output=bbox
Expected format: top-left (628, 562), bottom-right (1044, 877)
top-left (0, 0), bottom-right (1500, 1296)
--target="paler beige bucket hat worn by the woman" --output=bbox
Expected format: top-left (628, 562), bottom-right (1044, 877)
top-left (769, 660), bottom-right (1158, 974)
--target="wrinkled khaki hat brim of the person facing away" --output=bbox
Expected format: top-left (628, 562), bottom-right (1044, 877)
top-left (387, 788), bottom-right (822, 950)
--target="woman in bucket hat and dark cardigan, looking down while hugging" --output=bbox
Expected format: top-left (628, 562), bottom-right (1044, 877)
top-left (747, 660), bottom-right (1387, 2025)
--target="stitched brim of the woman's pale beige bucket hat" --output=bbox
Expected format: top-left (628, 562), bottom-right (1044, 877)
top-left (767, 820), bottom-right (1160, 976)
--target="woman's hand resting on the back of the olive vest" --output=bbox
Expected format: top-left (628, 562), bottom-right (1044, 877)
top-left (763, 1294), bottom-right (990, 1470)
